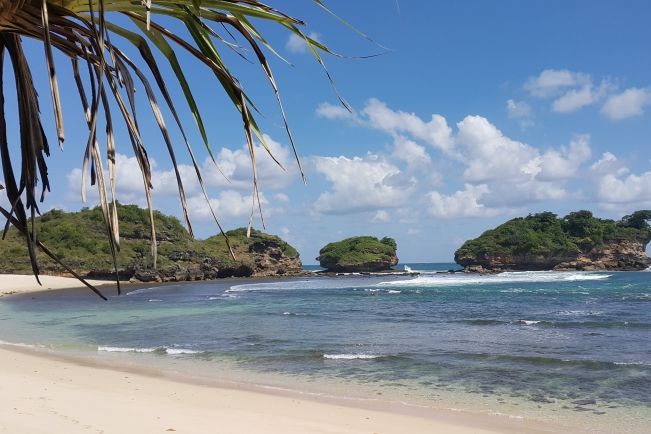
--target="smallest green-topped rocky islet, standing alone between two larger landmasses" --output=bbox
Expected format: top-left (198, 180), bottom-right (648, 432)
top-left (316, 236), bottom-right (398, 273)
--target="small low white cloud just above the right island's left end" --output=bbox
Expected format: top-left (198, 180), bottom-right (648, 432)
top-left (427, 184), bottom-right (499, 218)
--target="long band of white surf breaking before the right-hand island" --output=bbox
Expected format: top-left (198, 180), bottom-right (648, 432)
top-left (379, 271), bottom-right (611, 287)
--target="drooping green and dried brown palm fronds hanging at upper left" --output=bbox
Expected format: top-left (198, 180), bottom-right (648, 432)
top-left (0, 0), bottom-right (356, 297)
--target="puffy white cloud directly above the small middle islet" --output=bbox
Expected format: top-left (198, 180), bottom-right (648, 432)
top-left (313, 154), bottom-right (416, 214)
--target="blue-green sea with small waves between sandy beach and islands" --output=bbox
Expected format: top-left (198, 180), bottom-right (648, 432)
top-left (0, 264), bottom-right (651, 433)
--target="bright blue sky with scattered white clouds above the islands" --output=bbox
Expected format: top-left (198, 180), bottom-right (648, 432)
top-left (0, 0), bottom-right (651, 264)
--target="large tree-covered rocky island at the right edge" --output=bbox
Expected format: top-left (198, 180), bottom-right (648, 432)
top-left (454, 210), bottom-right (651, 272)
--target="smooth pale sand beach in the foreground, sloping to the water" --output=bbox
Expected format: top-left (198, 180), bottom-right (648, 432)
top-left (0, 344), bottom-right (564, 434)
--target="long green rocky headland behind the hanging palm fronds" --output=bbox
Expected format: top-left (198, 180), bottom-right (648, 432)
top-left (0, 205), bottom-right (303, 282)
